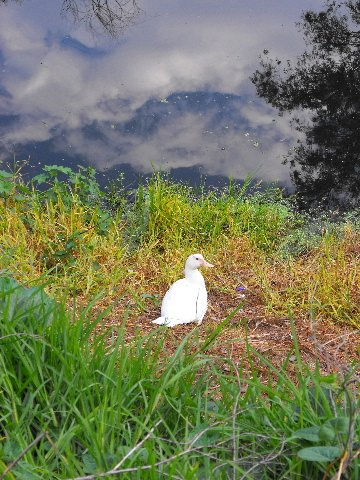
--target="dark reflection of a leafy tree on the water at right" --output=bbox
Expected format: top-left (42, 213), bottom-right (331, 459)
top-left (251, 0), bottom-right (360, 206)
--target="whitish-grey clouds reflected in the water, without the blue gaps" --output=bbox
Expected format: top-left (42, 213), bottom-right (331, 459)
top-left (0, 0), bottom-right (312, 184)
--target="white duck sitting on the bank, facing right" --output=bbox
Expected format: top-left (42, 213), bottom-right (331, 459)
top-left (152, 253), bottom-right (214, 327)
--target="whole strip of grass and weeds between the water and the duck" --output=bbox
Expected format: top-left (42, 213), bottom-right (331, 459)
top-left (0, 167), bottom-right (360, 326)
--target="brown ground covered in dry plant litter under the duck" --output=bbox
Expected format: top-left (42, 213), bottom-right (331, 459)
top-left (94, 284), bottom-right (360, 382)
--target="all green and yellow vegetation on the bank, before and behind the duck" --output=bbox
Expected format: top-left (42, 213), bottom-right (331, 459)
top-left (0, 166), bottom-right (360, 480)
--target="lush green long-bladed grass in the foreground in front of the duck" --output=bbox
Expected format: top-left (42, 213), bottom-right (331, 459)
top-left (0, 278), bottom-right (360, 480)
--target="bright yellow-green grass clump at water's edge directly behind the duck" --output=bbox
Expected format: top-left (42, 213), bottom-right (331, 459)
top-left (121, 174), bottom-right (295, 250)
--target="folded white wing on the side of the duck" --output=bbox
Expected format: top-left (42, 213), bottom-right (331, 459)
top-left (161, 278), bottom-right (199, 323)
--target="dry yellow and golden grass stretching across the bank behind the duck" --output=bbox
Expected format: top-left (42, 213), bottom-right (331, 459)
top-left (0, 182), bottom-right (360, 327)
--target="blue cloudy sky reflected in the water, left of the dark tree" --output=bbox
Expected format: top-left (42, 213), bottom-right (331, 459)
top-left (0, 0), bottom-right (322, 186)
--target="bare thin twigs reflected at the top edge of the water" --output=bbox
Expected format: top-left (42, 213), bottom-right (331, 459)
top-left (0, 0), bottom-right (141, 37)
